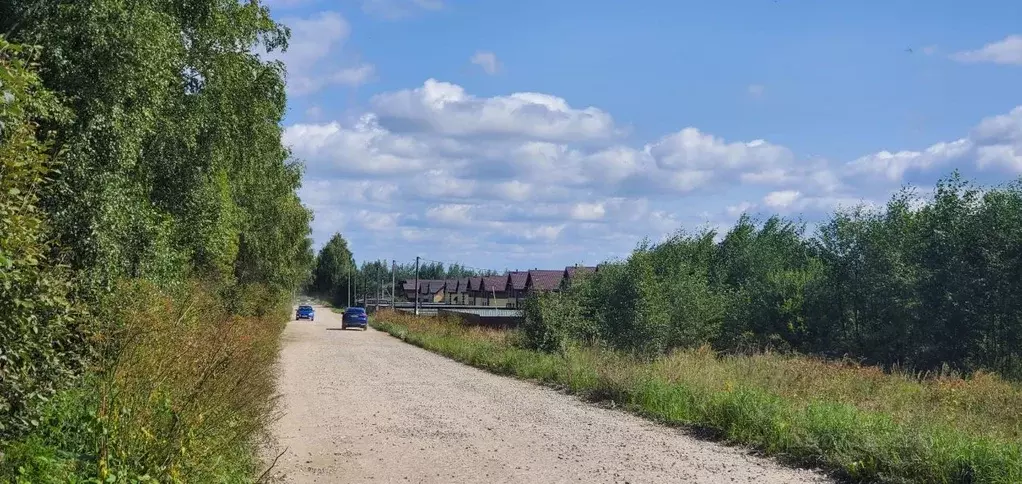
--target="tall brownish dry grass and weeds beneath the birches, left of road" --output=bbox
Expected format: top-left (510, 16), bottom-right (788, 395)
top-left (0, 282), bottom-right (287, 483)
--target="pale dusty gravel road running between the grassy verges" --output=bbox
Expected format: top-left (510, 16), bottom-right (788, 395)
top-left (266, 307), bottom-right (828, 484)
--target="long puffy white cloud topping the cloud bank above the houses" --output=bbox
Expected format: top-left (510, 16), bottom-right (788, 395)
top-left (371, 79), bottom-right (618, 141)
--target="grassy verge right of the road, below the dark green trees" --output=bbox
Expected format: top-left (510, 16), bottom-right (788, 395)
top-left (373, 313), bottom-right (1022, 483)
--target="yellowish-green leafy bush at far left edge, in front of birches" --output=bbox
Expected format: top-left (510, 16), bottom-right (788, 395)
top-left (0, 37), bottom-right (80, 442)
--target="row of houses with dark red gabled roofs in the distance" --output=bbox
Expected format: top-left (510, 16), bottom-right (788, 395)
top-left (402, 265), bottom-right (599, 307)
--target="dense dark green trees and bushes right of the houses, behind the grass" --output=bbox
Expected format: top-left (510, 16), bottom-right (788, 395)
top-left (524, 173), bottom-right (1022, 378)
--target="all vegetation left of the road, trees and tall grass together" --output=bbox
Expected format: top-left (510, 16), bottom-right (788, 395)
top-left (0, 0), bottom-right (313, 483)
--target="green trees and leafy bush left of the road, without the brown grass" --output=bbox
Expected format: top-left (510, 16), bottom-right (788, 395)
top-left (0, 0), bottom-right (314, 475)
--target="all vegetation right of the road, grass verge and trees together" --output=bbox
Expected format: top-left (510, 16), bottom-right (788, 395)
top-left (377, 175), bottom-right (1022, 483)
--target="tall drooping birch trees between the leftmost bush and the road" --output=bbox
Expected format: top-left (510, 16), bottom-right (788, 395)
top-left (0, 0), bottom-right (311, 296)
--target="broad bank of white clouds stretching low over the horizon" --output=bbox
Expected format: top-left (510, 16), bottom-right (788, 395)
top-left (284, 79), bottom-right (1022, 270)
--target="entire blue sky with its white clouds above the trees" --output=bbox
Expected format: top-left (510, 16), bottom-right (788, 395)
top-left (265, 0), bottom-right (1022, 270)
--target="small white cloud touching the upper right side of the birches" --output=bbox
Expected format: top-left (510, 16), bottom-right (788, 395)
top-left (269, 11), bottom-right (375, 96)
